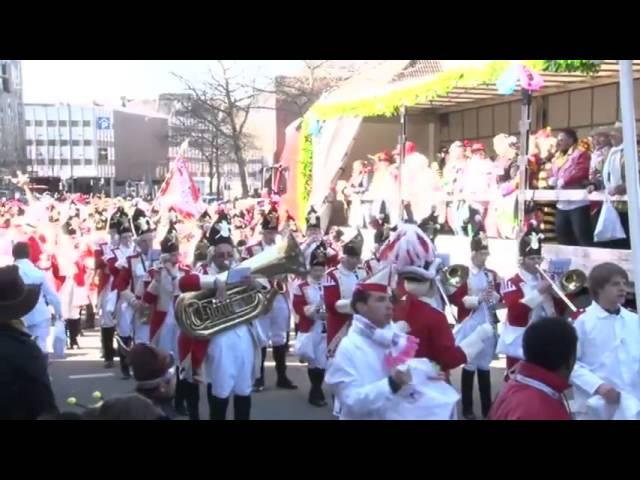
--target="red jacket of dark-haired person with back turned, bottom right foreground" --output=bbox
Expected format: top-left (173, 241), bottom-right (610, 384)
top-left (489, 361), bottom-right (571, 420)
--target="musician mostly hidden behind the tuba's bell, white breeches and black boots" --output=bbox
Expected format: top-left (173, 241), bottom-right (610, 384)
top-left (242, 202), bottom-right (298, 392)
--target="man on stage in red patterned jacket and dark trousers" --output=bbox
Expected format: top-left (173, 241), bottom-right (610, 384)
top-left (549, 128), bottom-right (593, 247)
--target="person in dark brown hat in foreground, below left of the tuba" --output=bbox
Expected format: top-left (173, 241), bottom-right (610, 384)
top-left (127, 343), bottom-right (176, 418)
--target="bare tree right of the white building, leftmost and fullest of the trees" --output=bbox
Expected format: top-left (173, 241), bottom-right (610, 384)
top-left (174, 61), bottom-right (258, 197)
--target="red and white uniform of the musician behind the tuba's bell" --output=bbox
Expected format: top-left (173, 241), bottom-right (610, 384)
top-left (242, 242), bottom-right (291, 347)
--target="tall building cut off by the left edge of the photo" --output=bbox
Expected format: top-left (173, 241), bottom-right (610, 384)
top-left (0, 60), bottom-right (28, 175)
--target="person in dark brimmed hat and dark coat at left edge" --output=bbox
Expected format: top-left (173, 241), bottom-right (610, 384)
top-left (0, 265), bottom-right (58, 420)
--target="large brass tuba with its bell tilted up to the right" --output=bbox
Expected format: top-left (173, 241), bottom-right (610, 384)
top-left (175, 234), bottom-right (307, 338)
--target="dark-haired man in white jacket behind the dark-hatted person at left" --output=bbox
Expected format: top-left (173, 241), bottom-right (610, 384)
top-left (12, 242), bottom-right (62, 356)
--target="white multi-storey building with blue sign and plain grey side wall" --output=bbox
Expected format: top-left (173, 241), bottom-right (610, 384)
top-left (24, 104), bottom-right (168, 193)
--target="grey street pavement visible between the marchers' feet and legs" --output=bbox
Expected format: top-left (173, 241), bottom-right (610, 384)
top-left (49, 330), bottom-right (504, 420)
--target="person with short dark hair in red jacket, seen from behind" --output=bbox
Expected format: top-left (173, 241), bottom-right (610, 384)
top-left (489, 317), bottom-right (578, 420)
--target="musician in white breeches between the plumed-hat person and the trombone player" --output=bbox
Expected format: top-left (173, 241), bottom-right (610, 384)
top-left (450, 232), bottom-right (500, 420)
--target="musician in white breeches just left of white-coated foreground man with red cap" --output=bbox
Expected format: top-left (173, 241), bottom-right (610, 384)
top-left (293, 241), bottom-right (327, 407)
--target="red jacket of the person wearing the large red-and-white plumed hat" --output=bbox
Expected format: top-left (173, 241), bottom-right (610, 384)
top-left (402, 294), bottom-right (467, 370)
